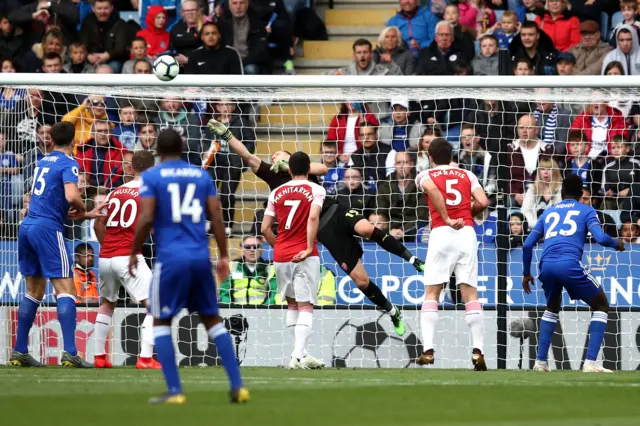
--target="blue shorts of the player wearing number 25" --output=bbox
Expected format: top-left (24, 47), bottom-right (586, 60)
top-left (539, 260), bottom-right (601, 303)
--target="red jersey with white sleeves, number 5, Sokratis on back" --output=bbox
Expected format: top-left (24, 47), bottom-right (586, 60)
top-left (416, 166), bottom-right (480, 229)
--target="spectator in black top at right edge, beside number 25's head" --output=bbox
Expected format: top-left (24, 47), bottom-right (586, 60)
top-left (602, 136), bottom-right (640, 213)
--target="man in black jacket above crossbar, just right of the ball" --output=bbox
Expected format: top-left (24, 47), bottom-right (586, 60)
top-left (185, 22), bottom-right (242, 74)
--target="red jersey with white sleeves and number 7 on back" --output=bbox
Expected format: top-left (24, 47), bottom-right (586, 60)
top-left (264, 180), bottom-right (326, 262)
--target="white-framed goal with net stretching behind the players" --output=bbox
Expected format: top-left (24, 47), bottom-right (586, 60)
top-left (0, 74), bottom-right (640, 369)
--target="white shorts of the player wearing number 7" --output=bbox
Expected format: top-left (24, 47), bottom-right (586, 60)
top-left (274, 256), bottom-right (320, 305)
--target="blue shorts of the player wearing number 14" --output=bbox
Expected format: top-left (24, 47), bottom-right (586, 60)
top-left (149, 253), bottom-right (218, 319)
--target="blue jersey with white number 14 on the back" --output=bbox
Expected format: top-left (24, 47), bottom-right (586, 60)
top-left (140, 160), bottom-right (216, 259)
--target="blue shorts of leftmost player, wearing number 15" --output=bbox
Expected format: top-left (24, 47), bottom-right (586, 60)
top-left (18, 224), bottom-right (73, 278)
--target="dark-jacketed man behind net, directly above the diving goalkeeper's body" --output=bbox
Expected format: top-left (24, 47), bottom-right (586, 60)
top-left (349, 122), bottom-right (391, 194)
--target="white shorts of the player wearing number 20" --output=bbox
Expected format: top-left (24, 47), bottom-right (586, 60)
top-left (98, 254), bottom-right (151, 303)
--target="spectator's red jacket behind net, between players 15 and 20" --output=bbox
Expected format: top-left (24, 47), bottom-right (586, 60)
top-left (76, 136), bottom-right (125, 189)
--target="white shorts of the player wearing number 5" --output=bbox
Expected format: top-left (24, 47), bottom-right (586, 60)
top-left (424, 226), bottom-right (478, 287)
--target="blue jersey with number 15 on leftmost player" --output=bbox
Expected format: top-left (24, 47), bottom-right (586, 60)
top-left (22, 151), bottom-right (79, 230)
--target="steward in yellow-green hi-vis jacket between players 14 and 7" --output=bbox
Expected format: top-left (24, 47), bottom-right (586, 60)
top-left (220, 237), bottom-right (277, 305)
